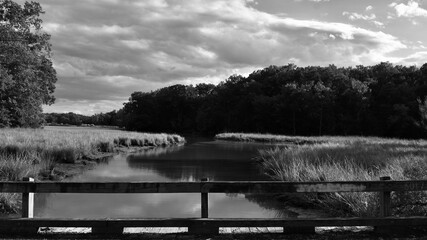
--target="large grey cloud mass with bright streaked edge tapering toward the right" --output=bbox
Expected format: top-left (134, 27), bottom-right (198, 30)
top-left (28, 0), bottom-right (406, 113)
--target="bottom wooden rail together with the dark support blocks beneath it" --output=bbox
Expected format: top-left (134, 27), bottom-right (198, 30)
top-left (0, 217), bottom-right (427, 235)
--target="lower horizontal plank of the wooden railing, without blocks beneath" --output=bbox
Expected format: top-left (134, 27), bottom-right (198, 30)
top-left (0, 217), bottom-right (427, 229)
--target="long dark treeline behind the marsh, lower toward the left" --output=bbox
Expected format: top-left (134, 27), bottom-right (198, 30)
top-left (45, 62), bottom-right (427, 138)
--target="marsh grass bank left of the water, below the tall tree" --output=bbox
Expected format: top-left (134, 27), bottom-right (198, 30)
top-left (0, 127), bottom-right (185, 213)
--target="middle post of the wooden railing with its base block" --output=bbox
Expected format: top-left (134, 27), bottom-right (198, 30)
top-left (188, 178), bottom-right (219, 235)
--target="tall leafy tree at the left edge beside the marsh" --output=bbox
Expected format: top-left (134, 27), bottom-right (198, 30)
top-left (0, 0), bottom-right (57, 127)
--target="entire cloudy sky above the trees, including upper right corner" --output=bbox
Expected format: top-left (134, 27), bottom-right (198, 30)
top-left (12, 0), bottom-right (427, 115)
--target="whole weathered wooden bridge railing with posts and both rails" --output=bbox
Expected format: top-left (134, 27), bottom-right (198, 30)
top-left (0, 177), bottom-right (427, 234)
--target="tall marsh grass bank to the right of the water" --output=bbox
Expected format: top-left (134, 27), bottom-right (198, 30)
top-left (216, 133), bottom-right (427, 216)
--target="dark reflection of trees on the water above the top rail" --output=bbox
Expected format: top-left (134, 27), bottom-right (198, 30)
top-left (126, 141), bottom-right (268, 181)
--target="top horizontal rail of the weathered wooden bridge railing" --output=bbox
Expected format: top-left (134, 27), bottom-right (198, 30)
top-left (0, 180), bottom-right (427, 193)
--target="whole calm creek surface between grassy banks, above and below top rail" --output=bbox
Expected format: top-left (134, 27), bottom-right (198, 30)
top-left (35, 140), bottom-right (296, 218)
